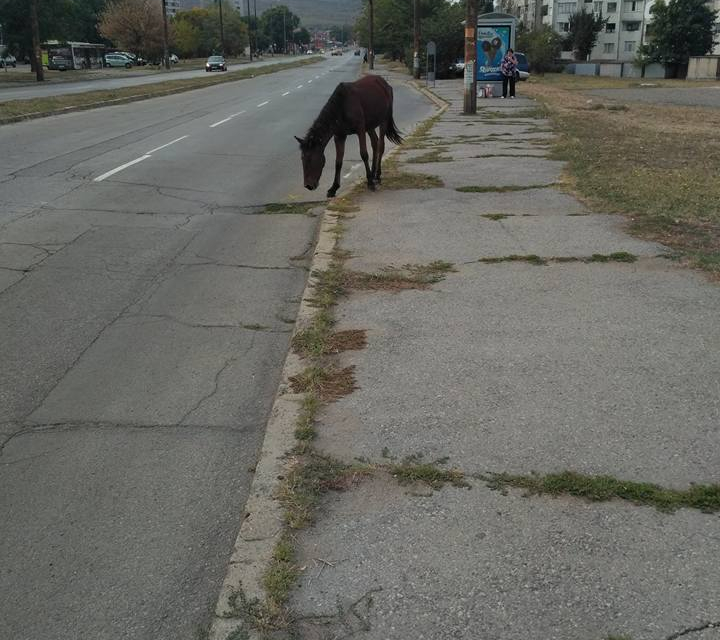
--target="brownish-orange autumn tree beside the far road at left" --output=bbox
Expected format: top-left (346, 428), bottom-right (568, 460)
top-left (99, 0), bottom-right (163, 58)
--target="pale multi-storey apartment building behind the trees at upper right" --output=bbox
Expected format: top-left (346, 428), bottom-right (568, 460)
top-left (518, 0), bottom-right (720, 62)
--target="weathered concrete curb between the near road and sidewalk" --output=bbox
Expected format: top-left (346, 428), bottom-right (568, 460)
top-left (208, 209), bottom-right (341, 640)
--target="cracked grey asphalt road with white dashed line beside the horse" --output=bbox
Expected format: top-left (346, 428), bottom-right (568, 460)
top-left (0, 56), bottom-right (431, 640)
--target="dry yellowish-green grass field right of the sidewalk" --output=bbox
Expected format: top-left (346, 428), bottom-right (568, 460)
top-left (528, 75), bottom-right (720, 277)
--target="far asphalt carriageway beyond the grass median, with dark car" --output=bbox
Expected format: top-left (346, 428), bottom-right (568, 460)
top-left (0, 56), bottom-right (300, 102)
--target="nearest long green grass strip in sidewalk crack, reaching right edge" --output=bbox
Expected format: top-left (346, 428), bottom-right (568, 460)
top-left (480, 471), bottom-right (720, 512)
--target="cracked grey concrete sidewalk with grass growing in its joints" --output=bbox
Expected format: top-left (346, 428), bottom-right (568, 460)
top-left (290, 81), bottom-right (720, 640)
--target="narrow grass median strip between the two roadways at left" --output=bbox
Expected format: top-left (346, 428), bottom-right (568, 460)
top-left (0, 56), bottom-right (324, 124)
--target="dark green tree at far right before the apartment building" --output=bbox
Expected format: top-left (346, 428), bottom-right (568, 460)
top-left (638, 0), bottom-right (717, 65)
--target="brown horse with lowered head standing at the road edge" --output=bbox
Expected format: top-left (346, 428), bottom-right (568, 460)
top-left (295, 76), bottom-right (402, 198)
